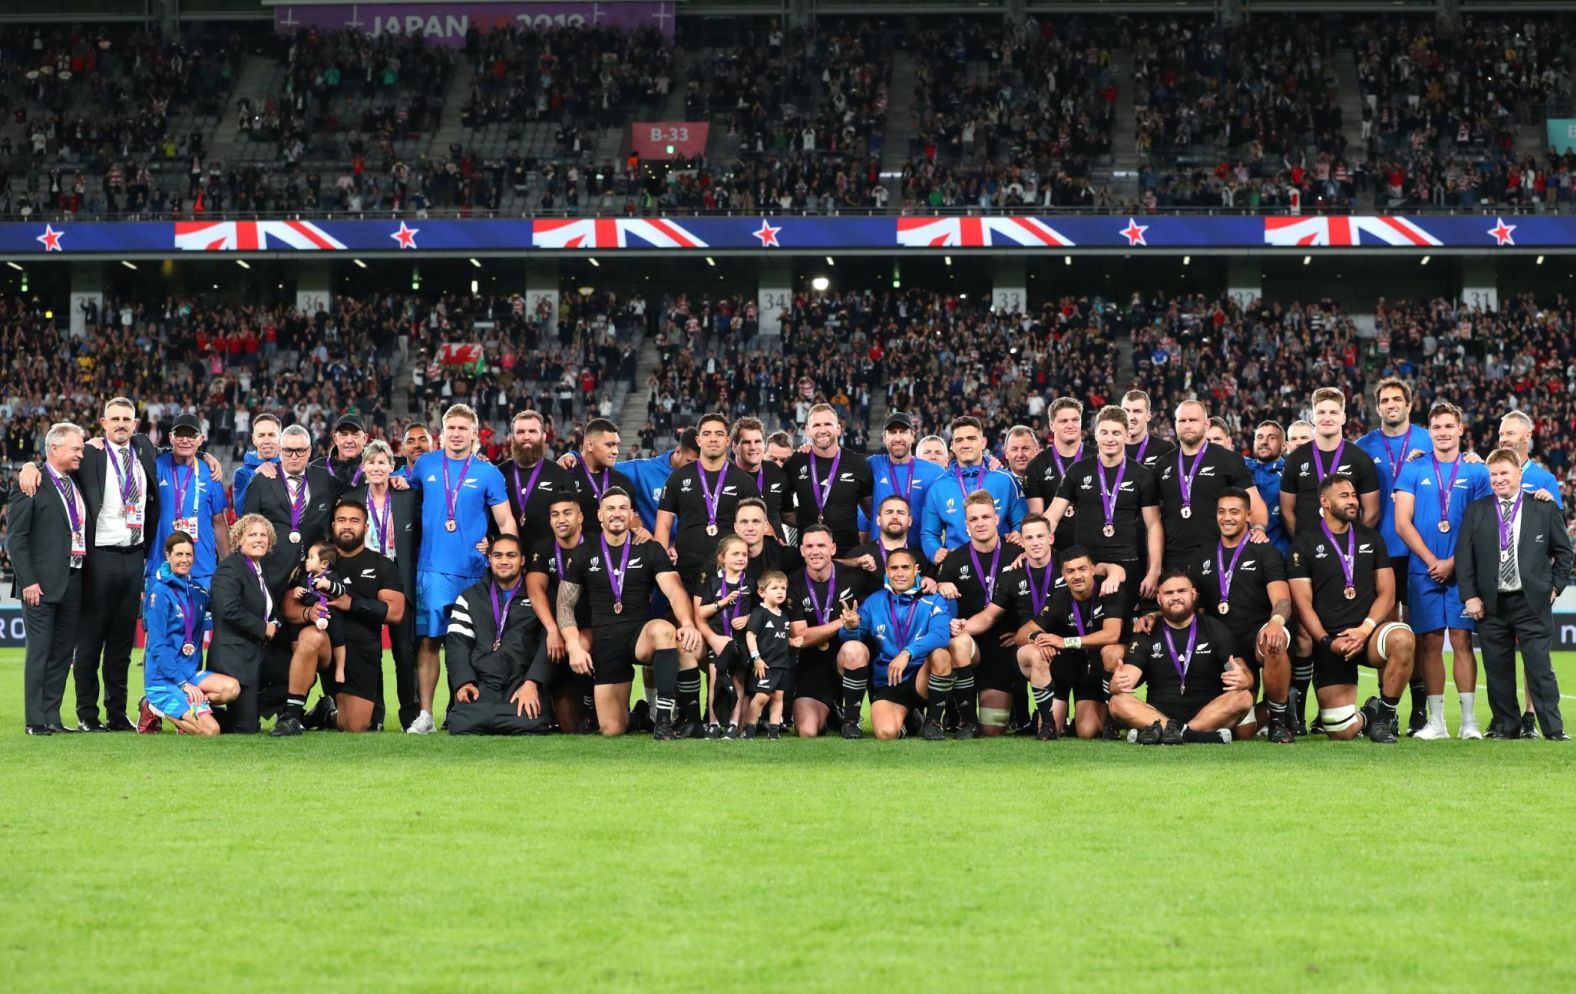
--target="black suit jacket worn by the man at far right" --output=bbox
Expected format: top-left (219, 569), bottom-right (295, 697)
top-left (1456, 495), bottom-right (1573, 614)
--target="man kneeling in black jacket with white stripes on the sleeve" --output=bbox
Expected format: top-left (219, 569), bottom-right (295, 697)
top-left (444, 536), bottom-right (552, 736)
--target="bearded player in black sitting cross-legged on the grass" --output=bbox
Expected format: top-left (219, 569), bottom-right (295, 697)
top-left (1111, 569), bottom-right (1253, 745)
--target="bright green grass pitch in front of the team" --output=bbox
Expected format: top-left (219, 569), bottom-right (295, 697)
top-left (0, 651), bottom-right (1576, 994)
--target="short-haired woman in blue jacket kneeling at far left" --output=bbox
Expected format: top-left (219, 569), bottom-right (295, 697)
top-left (137, 531), bottom-right (241, 736)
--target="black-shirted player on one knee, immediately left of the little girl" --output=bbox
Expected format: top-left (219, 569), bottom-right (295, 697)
top-left (556, 491), bottom-right (702, 740)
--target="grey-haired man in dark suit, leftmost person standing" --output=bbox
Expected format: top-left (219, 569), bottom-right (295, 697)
top-left (9, 422), bottom-right (88, 736)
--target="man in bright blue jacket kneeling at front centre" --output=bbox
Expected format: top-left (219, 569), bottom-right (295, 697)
top-left (838, 548), bottom-right (953, 742)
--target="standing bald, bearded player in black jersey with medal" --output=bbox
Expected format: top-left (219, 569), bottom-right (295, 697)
top-left (1155, 400), bottom-right (1267, 569)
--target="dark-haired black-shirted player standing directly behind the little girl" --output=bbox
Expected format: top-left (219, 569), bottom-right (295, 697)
top-left (652, 413), bottom-right (760, 592)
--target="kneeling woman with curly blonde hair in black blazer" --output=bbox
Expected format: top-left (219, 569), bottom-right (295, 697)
top-left (208, 514), bottom-right (279, 733)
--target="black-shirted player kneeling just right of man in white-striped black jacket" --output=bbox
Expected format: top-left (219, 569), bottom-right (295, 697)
top-left (525, 493), bottom-right (596, 733)
